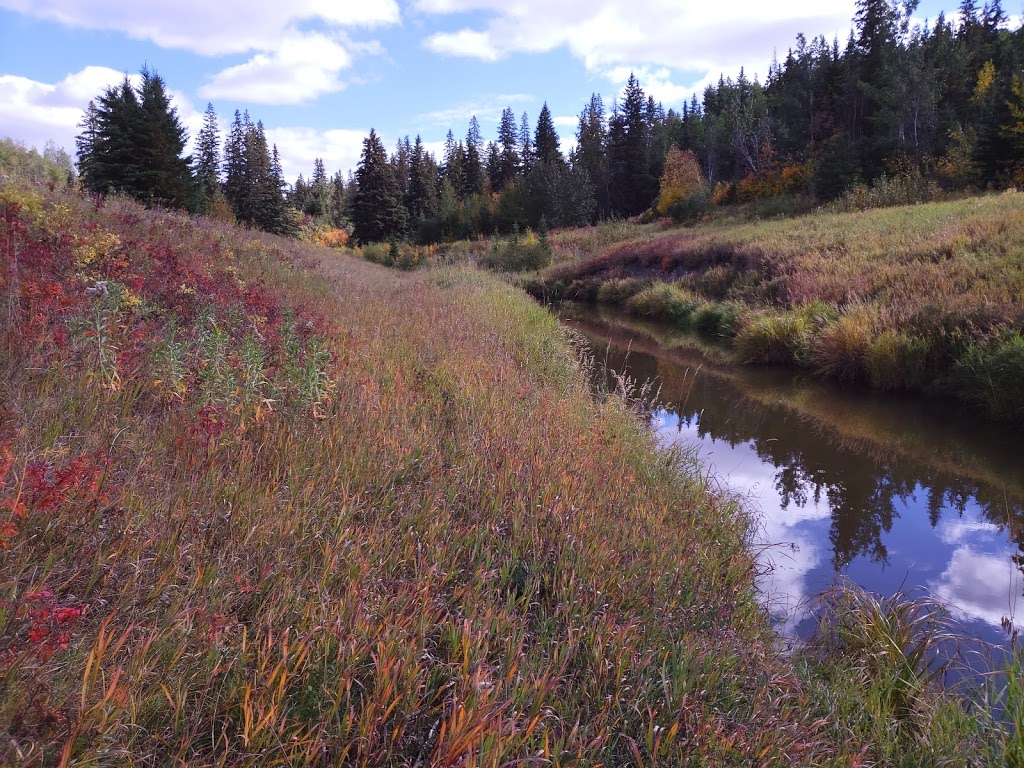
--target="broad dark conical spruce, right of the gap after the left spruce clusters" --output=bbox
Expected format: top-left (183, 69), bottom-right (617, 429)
top-left (352, 130), bottom-right (407, 243)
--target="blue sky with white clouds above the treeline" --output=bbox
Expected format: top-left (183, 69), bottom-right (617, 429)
top-left (0, 0), bottom-right (966, 181)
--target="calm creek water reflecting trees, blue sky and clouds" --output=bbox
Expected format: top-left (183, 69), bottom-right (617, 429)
top-left (563, 307), bottom-right (1024, 645)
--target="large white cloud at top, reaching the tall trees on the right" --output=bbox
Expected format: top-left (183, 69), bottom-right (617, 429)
top-left (415, 0), bottom-right (854, 103)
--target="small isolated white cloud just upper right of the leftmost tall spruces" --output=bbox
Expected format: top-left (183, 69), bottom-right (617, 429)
top-left (199, 34), bottom-right (352, 104)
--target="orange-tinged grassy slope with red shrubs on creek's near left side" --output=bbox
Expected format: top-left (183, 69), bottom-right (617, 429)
top-left (0, 145), bottom-right (1016, 767)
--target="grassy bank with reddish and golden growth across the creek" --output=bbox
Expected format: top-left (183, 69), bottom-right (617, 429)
top-left (532, 193), bottom-right (1024, 423)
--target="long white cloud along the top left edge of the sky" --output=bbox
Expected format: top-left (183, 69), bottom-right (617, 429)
top-left (0, 0), bottom-right (400, 55)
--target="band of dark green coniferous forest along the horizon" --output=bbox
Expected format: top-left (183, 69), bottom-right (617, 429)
top-left (78, 0), bottom-right (1024, 243)
